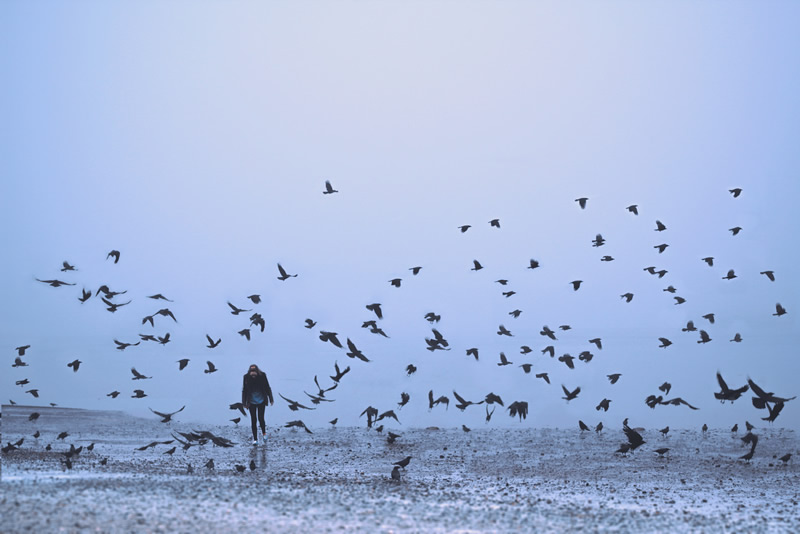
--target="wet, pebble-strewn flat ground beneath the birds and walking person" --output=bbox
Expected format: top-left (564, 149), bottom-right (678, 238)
top-left (0, 406), bottom-right (800, 533)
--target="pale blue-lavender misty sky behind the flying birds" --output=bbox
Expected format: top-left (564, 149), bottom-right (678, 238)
top-left (0, 1), bottom-right (800, 429)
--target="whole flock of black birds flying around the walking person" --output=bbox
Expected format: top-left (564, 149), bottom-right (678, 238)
top-left (3, 181), bottom-right (795, 479)
